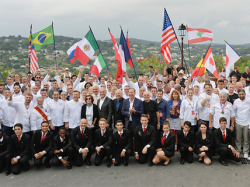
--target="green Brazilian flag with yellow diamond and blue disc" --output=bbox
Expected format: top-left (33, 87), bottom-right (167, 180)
top-left (32, 25), bottom-right (55, 51)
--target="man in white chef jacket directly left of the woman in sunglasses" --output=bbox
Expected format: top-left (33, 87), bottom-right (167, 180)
top-left (63, 90), bottom-right (83, 133)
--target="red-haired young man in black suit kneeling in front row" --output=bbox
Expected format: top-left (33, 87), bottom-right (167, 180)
top-left (95, 118), bottom-right (113, 168)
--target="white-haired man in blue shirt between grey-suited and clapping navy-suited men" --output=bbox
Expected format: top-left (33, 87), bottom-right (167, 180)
top-left (113, 90), bottom-right (125, 127)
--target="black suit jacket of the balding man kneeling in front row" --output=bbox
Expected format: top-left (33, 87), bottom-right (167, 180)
top-left (70, 126), bottom-right (93, 151)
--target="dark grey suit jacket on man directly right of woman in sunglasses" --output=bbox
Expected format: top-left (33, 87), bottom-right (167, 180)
top-left (97, 96), bottom-right (113, 127)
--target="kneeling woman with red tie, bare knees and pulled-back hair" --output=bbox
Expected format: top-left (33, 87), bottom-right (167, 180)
top-left (153, 121), bottom-right (176, 166)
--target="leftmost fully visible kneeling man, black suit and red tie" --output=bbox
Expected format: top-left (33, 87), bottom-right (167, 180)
top-left (11, 123), bottom-right (30, 175)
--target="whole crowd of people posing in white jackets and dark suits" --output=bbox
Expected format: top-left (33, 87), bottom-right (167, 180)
top-left (0, 63), bottom-right (250, 175)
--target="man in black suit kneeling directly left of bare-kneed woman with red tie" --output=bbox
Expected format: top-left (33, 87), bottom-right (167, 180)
top-left (134, 114), bottom-right (156, 167)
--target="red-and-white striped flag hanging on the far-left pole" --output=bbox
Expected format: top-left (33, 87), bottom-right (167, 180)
top-left (29, 27), bottom-right (39, 73)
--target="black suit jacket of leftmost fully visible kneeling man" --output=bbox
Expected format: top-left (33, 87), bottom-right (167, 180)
top-left (11, 134), bottom-right (31, 158)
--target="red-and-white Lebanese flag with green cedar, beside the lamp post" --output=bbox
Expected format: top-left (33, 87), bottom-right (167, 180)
top-left (187, 27), bottom-right (213, 44)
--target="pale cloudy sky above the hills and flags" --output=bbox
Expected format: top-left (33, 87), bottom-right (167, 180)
top-left (0, 0), bottom-right (250, 44)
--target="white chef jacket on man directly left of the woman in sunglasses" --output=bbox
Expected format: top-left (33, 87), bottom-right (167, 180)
top-left (63, 100), bottom-right (83, 129)
